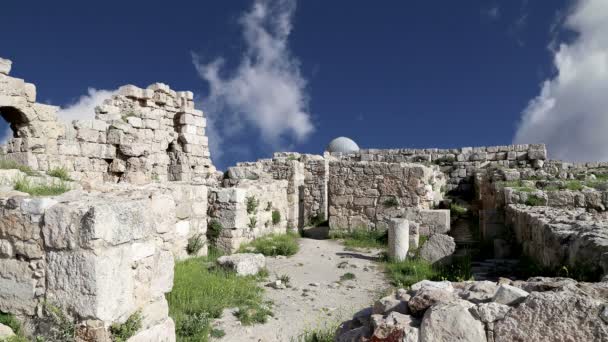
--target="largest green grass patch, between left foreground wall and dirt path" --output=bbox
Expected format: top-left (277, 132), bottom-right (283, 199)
top-left (167, 248), bottom-right (270, 342)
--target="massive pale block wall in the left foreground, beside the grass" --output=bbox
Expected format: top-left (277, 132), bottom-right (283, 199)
top-left (0, 183), bottom-right (207, 341)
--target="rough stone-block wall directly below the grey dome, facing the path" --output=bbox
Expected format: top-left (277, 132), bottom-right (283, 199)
top-left (328, 161), bottom-right (445, 229)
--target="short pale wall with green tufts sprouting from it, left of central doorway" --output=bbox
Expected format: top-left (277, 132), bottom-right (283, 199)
top-left (209, 179), bottom-right (289, 253)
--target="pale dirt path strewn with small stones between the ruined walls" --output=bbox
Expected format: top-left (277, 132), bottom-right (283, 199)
top-left (215, 239), bottom-right (389, 342)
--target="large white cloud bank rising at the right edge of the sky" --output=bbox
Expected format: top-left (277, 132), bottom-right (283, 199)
top-left (514, 0), bottom-right (608, 161)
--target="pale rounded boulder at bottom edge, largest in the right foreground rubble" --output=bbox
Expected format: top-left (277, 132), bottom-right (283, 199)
top-left (420, 300), bottom-right (487, 342)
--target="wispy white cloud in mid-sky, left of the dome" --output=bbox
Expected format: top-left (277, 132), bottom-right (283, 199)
top-left (193, 0), bottom-right (314, 158)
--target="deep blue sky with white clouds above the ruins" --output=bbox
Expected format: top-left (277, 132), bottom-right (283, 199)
top-left (0, 0), bottom-right (608, 168)
